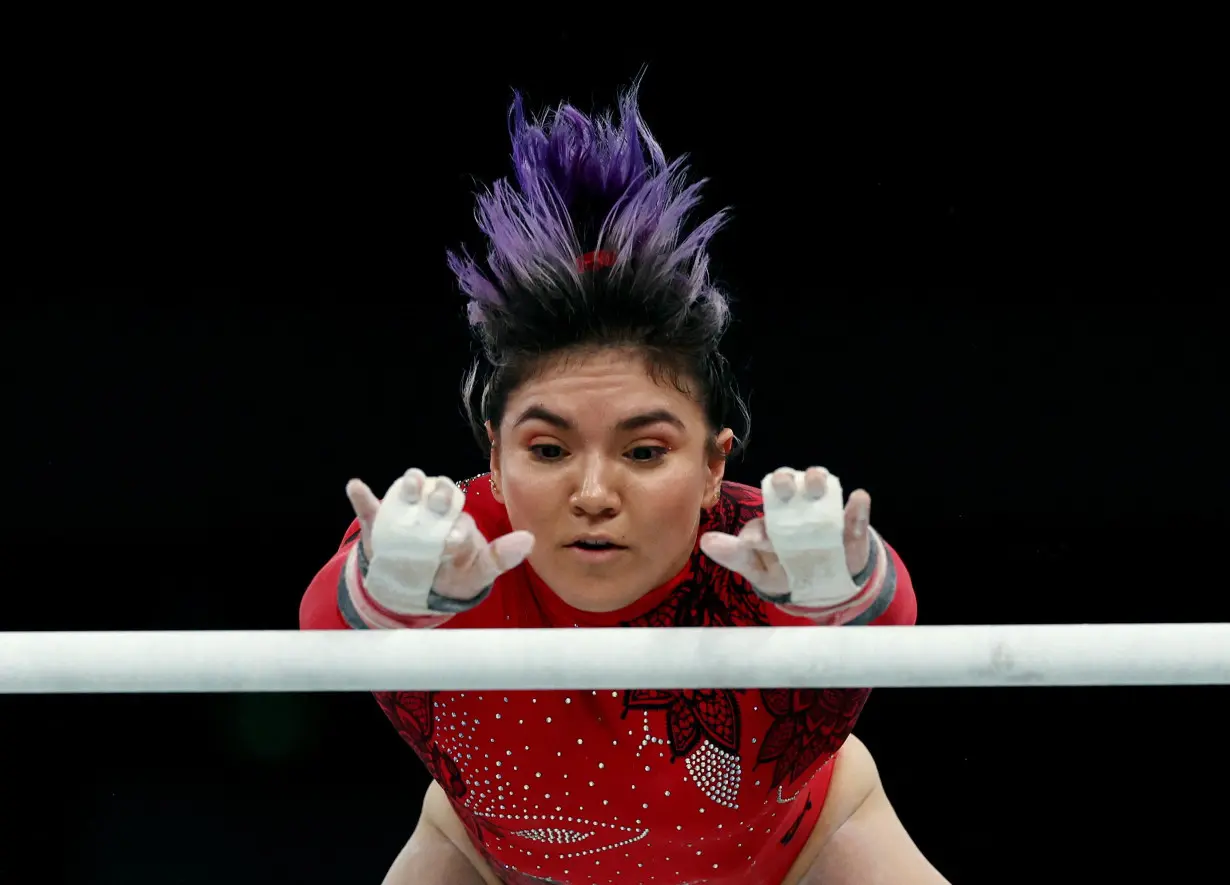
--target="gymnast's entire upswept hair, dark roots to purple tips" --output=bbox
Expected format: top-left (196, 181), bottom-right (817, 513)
top-left (448, 79), bottom-right (747, 450)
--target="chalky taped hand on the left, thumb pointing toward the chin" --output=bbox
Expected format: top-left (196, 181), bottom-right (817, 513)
top-left (346, 468), bottom-right (534, 612)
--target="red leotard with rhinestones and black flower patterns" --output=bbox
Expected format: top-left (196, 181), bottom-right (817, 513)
top-left (300, 476), bottom-right (916, 885)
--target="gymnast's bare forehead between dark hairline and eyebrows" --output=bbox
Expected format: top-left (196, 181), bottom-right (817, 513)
top-left (508, 350), bottom-right (704, 423)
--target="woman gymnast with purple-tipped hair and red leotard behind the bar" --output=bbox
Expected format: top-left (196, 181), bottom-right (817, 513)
top-left (300, 81), bottom-right (943, 885)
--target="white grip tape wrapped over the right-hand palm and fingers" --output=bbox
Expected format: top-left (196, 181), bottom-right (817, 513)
top-left (760, 471), bottom-right (859, 607)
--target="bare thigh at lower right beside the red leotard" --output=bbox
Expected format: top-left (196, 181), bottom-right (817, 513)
top-left (798, 741), bottom-right (948, 885)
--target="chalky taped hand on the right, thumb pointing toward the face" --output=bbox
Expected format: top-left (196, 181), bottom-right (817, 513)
top-left (700, 467), bottom-right (871, 606)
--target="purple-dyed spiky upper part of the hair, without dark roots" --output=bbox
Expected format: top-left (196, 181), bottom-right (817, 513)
top-left (448, 75), bottom-right (727, 326)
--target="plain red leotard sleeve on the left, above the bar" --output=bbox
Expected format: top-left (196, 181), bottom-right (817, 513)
top-left (299, 520), bottom-right (453, 629)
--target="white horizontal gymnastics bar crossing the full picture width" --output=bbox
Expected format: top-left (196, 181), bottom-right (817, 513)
top-left (0, 623), bottom-right (1230, 693)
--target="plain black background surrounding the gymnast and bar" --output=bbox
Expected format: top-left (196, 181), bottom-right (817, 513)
top-left (0, 11), bottom-right (1230, 885)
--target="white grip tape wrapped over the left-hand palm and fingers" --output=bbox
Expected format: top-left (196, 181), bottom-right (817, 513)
top-left (364, 477), bottom-right (465, 615)
